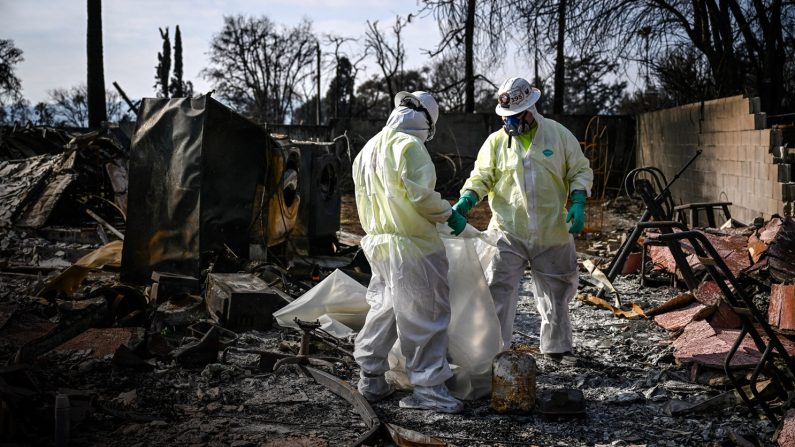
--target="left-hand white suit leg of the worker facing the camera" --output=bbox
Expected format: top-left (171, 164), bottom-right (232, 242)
top-left (486, 238), bottom-right (527, 349)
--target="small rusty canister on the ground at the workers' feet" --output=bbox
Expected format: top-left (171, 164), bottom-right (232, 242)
top-left (491, 351), bottom-right (536, 413)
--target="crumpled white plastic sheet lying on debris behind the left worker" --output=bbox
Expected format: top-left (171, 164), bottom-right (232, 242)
top-left (273, 270), bottom-right (370, 338)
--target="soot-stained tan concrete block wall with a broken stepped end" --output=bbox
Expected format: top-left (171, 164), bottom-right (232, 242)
top-left (636, 96), bottom-right (784, 223)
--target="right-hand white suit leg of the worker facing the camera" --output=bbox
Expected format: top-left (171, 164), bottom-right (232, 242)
top-left (532, 242), bottom-right (579, 353)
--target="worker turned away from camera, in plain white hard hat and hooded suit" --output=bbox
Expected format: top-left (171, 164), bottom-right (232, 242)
top-left (352, 91), bottom-right (466, 413)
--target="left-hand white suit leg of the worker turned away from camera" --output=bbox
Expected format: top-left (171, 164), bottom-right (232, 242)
top-left (353, 269), bottom-right (397, 402)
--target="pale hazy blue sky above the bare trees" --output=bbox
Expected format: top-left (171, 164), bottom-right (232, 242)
top-left (0, 0), bottom-right (530, 104)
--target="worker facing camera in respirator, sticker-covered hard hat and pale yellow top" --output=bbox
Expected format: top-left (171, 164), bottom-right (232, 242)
top-left (453, 78), bottom-right (593, 360)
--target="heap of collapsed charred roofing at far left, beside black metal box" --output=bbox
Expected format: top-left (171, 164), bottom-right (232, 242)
top-left (0, 122), bottom-right (129, 234)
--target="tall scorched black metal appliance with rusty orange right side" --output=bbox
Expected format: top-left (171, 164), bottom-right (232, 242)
top-left (121, 95), bottom-right (301, 283)
